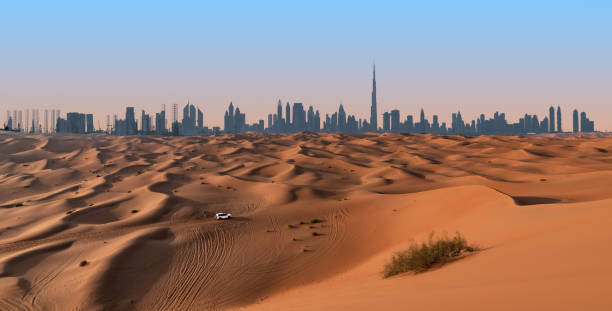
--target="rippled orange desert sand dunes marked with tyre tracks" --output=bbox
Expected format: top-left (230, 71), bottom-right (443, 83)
top-left (0, 133), bottom-right (612, 310)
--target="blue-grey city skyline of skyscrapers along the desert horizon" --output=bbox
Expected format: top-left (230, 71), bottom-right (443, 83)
top-left (5, 68), bottom-right (595, 136)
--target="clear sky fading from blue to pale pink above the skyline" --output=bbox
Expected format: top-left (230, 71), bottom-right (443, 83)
top-left (0, 0), bottom-right (612, 131)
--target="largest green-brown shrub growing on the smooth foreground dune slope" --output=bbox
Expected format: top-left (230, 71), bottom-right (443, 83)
top-left (383, 232), bottom-right (478, 278)
